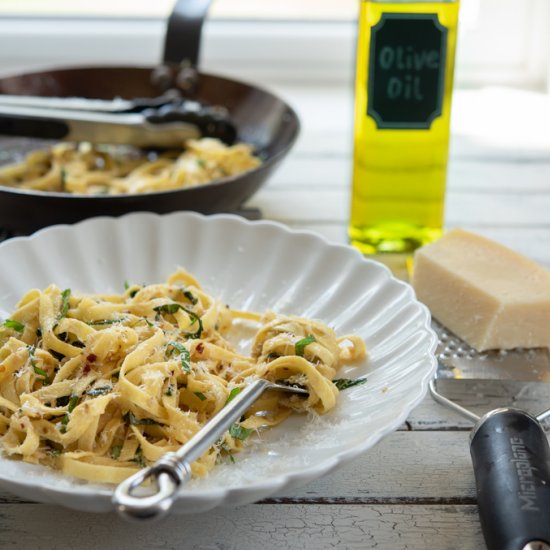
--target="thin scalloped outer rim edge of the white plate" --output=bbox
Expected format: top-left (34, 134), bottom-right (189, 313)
top-left (0, 211), bottom-right (437, 513)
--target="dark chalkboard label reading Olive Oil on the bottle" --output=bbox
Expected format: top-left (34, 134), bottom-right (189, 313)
top-left (367, 13), bottom-right (447, 130)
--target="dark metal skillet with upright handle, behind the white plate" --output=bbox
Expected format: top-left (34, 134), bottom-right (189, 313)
top-left (0, 0), bottom-right (299, 233)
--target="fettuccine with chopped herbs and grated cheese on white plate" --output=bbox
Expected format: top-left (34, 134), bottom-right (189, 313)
top-left (0, 270), bottom-right (366, 483)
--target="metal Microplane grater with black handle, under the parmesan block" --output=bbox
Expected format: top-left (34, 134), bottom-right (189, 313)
top-left (430, 321), bottom-right (550, 550)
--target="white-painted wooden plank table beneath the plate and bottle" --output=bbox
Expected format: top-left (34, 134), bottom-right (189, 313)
top-left (0, 86), bottom-right (550, 550)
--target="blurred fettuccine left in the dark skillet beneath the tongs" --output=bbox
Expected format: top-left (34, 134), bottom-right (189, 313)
top-left (0, 138), bottom-right (261, 195)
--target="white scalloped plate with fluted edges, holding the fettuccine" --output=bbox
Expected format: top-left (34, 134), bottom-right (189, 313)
top-left (0, 212), bottom-right (436, 512)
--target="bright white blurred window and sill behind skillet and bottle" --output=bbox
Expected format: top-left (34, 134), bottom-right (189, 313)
top-left (0, 0), bottom-right (550, 90)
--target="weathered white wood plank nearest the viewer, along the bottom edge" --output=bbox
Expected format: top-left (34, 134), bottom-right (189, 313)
top-left (0, 504), bottom-right (483, 550)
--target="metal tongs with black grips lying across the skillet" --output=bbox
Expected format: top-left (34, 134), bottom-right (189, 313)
top-left (0, 93), bottom-right (237, 148)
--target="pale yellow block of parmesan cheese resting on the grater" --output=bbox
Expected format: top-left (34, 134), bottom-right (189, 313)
top-left (412, 229), bottom-right (550, 351)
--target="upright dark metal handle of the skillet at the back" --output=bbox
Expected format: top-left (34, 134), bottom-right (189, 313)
top-left (163, 0), bottom-right (212, 67)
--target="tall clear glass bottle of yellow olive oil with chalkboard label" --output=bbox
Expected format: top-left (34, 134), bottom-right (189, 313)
top-left (348, 0), bottom-right (459, 254)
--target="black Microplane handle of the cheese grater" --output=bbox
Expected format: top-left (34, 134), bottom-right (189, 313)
top-left (470, 408), bottom-right (550, 550)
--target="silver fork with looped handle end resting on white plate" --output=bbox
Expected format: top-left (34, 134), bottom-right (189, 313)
top-left (113, 379), bottom-right (309, 520)
